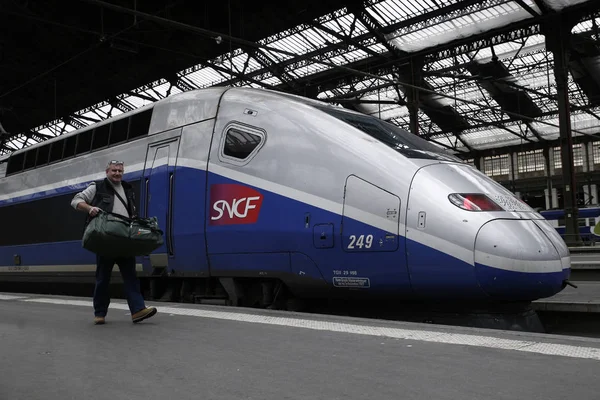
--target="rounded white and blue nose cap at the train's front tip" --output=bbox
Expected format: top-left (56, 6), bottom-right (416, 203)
top-left (475, 220), bottom-right (564, 301)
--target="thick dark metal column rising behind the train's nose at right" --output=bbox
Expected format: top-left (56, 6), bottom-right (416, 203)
top-left (545, 15), bottom-right (581, 246)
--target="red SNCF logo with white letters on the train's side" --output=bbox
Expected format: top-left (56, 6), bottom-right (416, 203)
top-left (210, 184), bottom-right (263, 225)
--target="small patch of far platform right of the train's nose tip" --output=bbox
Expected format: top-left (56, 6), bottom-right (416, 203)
top-left (532, 282), bottom-right (600, 312)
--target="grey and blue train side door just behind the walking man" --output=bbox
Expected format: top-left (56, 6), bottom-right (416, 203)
top-left (140, 129), bottom-right (181, 268)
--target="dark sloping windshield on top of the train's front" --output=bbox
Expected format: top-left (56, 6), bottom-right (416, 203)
top-left (318, 107), bottom-right (462, 162)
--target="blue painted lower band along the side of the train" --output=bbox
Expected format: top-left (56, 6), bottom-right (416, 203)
top-left (0, 167), bottom-right (562, 299)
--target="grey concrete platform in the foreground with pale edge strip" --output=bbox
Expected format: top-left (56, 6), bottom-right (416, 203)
top-left (0, 293), bottom-right (600, 400)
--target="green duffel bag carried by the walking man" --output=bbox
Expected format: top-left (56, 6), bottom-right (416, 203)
top-left (82, 211), bottom-right (164, 257)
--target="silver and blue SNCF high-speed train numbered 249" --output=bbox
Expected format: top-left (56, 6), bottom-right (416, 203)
top-left (0, 87), bottom-right (570, 304)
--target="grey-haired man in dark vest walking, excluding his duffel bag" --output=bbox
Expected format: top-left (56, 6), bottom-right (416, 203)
top-left (71, 160), bottom-right (156, 325)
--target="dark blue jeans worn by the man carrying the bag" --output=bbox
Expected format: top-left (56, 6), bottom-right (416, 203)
top-left (94, 255), bottom-right (146, 317)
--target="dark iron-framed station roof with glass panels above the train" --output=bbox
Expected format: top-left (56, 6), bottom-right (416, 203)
top-left (0, 0), bottom-right (600, 156)
